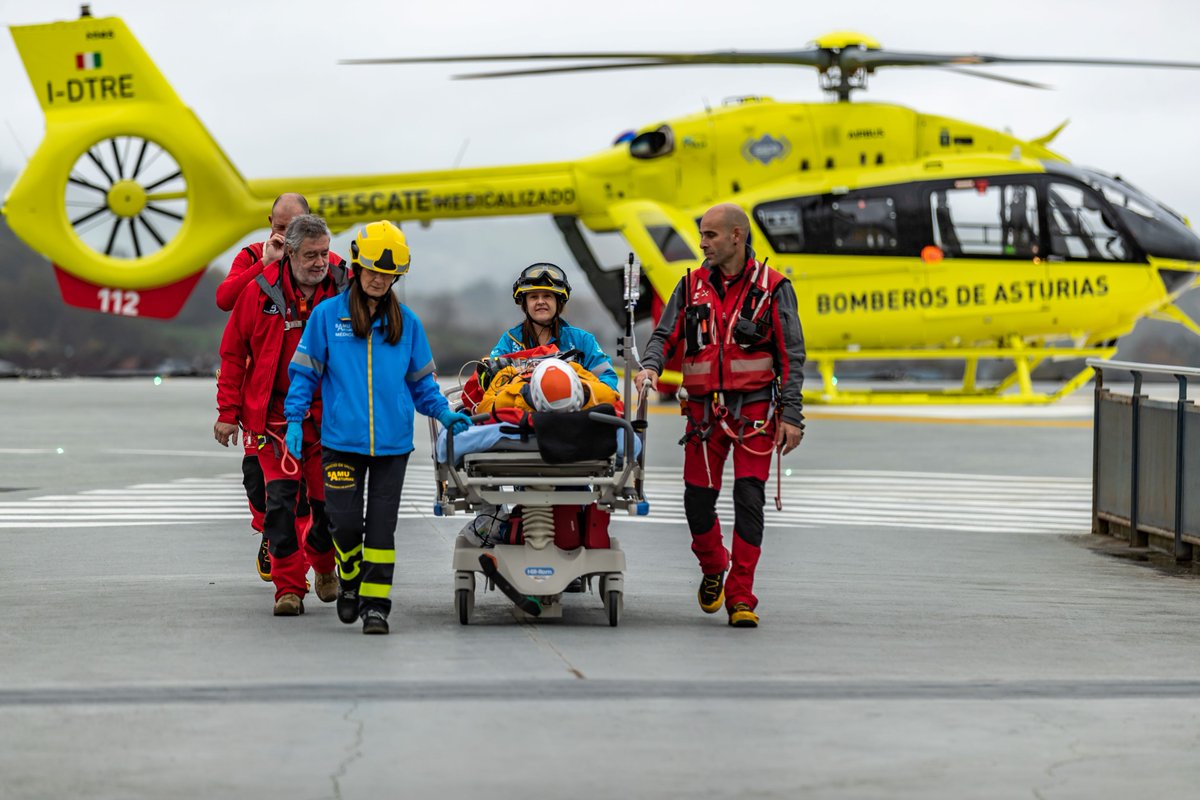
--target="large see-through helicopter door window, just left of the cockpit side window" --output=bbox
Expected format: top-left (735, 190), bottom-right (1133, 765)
top-left (929, 179), bottom-right (1040, 258)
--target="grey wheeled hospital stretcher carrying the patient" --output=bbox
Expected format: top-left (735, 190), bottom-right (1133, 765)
top-left (431, 381), bottom-right (648, 626)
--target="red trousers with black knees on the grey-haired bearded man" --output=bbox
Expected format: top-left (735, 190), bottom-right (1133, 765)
top-left (258, 420), bottom-right (335, 600)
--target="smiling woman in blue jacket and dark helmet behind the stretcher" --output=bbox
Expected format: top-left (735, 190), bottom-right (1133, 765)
top-left (491, 261), bottom-right (617, 389)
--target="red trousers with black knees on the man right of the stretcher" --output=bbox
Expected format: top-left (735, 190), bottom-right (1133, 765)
top-left (683, 401), bottom-right (775, 608)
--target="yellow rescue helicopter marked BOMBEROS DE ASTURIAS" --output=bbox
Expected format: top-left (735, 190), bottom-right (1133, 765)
top-left (4, 9), bottom-right (1200, 403)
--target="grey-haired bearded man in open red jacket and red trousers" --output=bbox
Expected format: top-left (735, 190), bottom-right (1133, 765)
top-left (212, 215), bottom-right (346, 616)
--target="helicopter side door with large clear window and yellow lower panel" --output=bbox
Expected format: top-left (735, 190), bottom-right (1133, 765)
top-left (925, 176), bottom-right (1050, 343)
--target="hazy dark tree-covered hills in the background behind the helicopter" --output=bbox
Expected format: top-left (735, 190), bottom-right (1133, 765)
top-left (0, 223), bottom-right (1200, 379)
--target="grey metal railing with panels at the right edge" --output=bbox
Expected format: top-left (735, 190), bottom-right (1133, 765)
top-left (1087, 359), bottom-right (1200, 561)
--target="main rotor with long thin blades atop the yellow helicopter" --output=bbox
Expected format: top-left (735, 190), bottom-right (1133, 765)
top-left (341, 31), bottom-right (1200, 101)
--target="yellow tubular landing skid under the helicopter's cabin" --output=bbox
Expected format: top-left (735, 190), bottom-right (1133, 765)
top-left (804, 341), bottom-right (1117, 405)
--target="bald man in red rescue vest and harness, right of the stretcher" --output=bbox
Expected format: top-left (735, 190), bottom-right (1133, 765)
top-left (635, 203), bottom-right (804, 627)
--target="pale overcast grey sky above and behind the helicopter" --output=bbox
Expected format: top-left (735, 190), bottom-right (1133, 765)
top-left (0, 0), bottom-right (1200, 303)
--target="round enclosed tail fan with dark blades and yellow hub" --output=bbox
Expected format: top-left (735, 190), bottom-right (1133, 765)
top-left (64, 136), bottom-right (187, 259)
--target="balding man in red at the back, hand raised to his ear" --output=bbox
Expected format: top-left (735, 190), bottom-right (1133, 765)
top-left (217, 192), bottom-right (342, 582)
